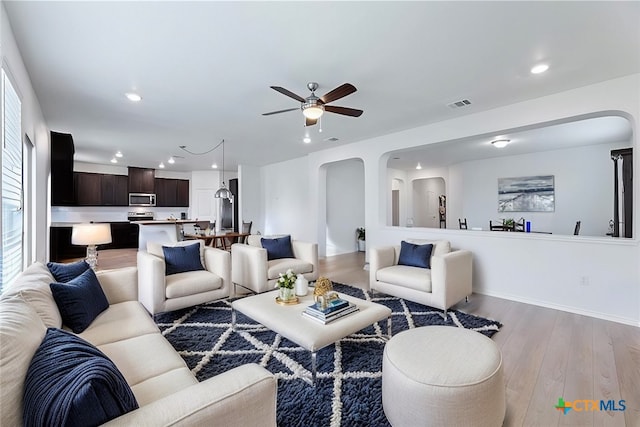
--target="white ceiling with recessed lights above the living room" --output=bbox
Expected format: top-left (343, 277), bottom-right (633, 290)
top-left (3, 0), bottom-right (640, 171)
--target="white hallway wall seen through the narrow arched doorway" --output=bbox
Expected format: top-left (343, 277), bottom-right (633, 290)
top-left (326, 159), bottom-right (364, 256)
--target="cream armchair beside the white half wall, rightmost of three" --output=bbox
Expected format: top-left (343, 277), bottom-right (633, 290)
top-left (369, 240), bottom-right (472, 320)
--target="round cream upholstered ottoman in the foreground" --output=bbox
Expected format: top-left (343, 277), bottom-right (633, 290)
top-left (382, 326), bottom-right (506, 427)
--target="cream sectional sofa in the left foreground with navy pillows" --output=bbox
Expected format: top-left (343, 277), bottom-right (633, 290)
top-left (0, 263), bottom-right (277, 426)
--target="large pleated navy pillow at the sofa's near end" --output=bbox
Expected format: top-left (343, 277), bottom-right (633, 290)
top-left (23, 328), bottom-right (138, 427)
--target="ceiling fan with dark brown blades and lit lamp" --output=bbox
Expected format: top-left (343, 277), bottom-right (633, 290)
top-left (262, 82), bottom-right (363, 126)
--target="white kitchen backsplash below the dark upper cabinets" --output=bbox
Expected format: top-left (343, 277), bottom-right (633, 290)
top-left (51, 206), bottom-right (190, 223)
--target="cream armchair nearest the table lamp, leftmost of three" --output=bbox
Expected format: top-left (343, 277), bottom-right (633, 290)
top-left (138, 240), bottom-right (231, 314)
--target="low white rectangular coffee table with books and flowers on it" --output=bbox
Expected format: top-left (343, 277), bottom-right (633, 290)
top-left (231, 288), bottom-right (391, 385)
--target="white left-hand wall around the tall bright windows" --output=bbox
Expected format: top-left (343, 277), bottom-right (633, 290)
top-left (0, 3), bottom-right (50, 264)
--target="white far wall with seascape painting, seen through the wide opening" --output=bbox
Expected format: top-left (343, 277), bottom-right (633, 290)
top-left (449, 142), bottom-right (629, 236)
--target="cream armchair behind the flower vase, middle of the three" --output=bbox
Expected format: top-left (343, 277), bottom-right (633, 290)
top-left (231, 234), bottom-right (318, 293)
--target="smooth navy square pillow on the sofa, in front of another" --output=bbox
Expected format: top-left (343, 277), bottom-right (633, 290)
top-left (49, 269), bottom-right (109, 334)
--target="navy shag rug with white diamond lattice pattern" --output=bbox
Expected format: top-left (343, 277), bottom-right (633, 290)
top-left (155, 283), bottom-right (502, 427)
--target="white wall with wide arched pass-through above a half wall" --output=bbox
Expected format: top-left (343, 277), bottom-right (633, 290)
top-left (263, 74), bottom-right (640, 325)
